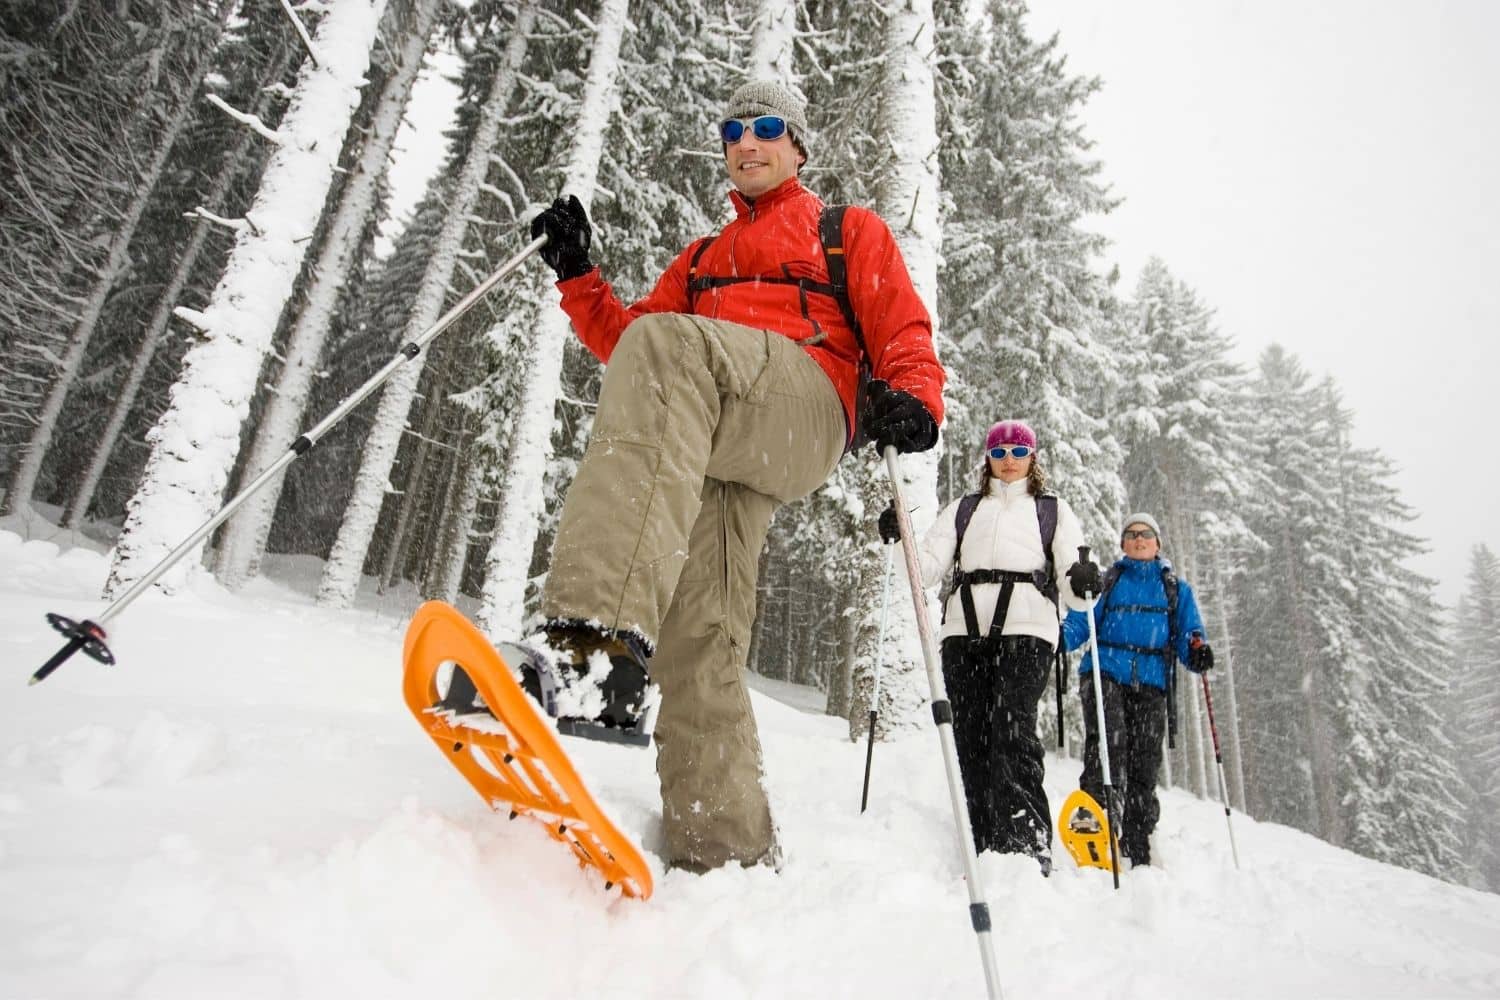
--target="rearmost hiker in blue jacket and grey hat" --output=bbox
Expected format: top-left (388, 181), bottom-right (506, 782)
top-left (1062, 513), bottom-right (1214, 865)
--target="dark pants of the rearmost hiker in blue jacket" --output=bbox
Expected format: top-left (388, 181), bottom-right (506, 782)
top-left (1079, 672), bottom-right (1167, 865)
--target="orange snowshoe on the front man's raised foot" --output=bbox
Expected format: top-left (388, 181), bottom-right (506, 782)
top-left (402, 601), bottom-right (651, 900)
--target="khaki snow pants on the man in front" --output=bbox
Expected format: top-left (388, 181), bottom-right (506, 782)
top-left (542, 313), bottom-right (845, 870)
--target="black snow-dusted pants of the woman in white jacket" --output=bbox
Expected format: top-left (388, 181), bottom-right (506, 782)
top-left (942, 636), bottom-right (1053, 858)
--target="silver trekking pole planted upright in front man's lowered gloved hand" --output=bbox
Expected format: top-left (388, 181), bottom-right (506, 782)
top-left (884, 445), bottom-right (1001, 1000)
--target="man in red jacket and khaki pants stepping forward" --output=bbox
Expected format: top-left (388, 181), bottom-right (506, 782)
top-left (533, 82), bottom-right (945, 870)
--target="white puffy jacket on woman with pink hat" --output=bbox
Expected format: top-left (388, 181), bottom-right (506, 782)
top-left (917, 478), bottom-right (1088, 645)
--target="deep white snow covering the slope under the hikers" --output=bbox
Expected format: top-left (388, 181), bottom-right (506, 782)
top-left (0, 531), bottom-right (1500, 1000)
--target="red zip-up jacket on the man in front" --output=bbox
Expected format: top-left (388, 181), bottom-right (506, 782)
top-left (558, 177), bottom-right (947, 440)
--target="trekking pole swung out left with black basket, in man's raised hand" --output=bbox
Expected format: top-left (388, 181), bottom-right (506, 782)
top-left (29, 235), bottom-right (548, 684)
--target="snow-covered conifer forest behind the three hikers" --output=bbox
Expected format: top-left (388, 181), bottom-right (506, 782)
top-left (0, 0), bottom-right (1500, 891)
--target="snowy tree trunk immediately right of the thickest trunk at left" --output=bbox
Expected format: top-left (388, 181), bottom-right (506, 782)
top-left (216, 0), bottom-right (438, 591)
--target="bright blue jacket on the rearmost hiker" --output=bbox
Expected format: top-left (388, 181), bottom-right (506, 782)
top-left (1062, 559), bottom-right (1203, 690)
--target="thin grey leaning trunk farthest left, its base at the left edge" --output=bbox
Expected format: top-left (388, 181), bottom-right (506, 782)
top-left (6, 11), bottom-right (230, 513)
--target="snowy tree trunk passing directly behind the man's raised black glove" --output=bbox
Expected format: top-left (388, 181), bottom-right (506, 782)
top-left (479, 0), bottom-right (629, 637)
